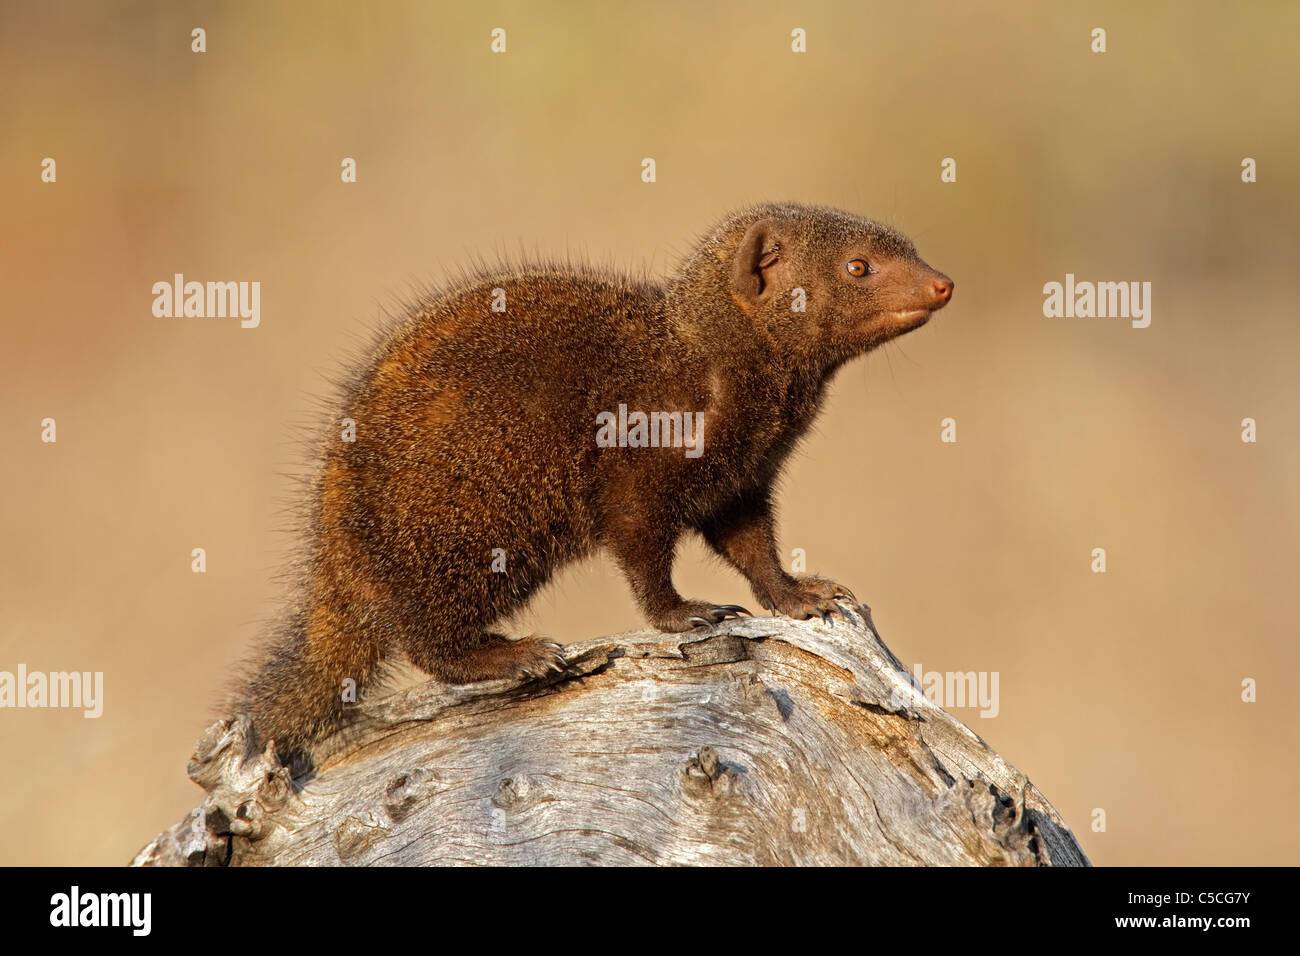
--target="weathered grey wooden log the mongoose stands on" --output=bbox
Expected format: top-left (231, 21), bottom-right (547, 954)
top-left (134, 607), bottom-right (1088, 866)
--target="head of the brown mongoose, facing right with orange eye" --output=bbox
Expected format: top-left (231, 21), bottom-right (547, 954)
top-left (715, 204), bottom-right (954, 363)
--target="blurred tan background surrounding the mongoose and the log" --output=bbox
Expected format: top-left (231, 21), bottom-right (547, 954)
top-left (0, 3), bottom-right (1300, 864)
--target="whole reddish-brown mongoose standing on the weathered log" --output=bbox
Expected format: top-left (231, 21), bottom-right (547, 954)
top-left (233, 204), bottom-right (952, 756)
